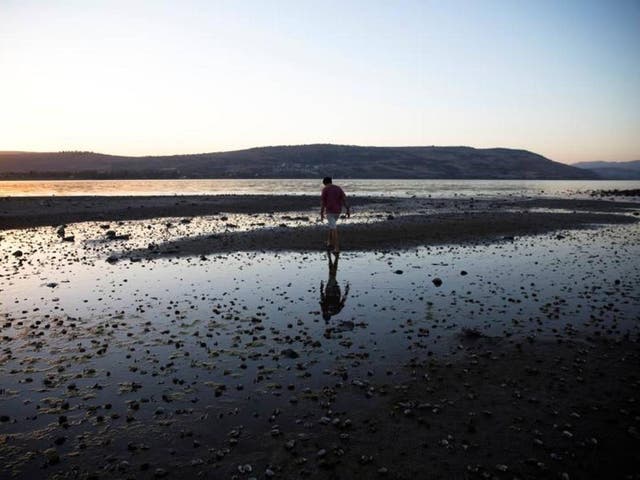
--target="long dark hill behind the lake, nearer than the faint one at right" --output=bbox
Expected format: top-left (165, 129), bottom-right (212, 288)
top-left (0, 144), bottom-right (598, 179)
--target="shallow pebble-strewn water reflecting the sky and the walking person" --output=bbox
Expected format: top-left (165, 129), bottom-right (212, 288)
top-left (0, 215), bottom-right (640, 476)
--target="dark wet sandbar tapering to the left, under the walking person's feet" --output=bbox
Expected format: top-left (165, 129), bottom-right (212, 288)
top-left (119, 212), bottom-right (637, 258)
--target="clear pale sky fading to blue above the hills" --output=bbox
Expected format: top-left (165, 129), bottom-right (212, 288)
top-left (0, 0), bottom-right (640, 163)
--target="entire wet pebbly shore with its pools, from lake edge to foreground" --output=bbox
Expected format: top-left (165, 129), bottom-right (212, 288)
top-left (0, 197), bottom-right (640, 479)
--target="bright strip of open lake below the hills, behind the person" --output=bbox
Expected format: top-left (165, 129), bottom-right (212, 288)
top-left (0, 179), bottom-right (640, 197)
